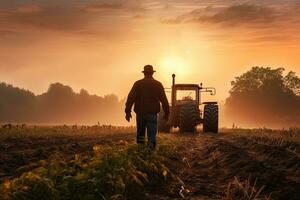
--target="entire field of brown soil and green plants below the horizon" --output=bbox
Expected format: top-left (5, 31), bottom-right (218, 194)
top-left (0, 126), bottom-right (300, 200)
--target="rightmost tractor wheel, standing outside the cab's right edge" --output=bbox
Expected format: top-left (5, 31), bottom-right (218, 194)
top-left (203, 104), bottom-right (219, 133)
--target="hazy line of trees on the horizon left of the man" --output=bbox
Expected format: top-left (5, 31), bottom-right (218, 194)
top-left (0, 83), bottom-right (124, 124)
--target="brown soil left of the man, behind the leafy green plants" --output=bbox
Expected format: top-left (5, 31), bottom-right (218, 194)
top-left (0, 127), bottom-right (135, 182)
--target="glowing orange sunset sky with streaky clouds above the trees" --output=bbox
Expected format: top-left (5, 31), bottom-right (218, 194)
top-left (0, 0), bottom-right (300, 101)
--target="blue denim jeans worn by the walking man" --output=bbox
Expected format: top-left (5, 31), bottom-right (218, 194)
top-left (136, 114), bottom-right (157, 147)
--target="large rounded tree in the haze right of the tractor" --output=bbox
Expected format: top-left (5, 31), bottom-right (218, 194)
top-left (225, 67), bottom-right (300, 126)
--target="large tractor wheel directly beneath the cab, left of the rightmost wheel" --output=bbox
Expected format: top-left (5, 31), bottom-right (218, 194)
top-left (179, 104), bottom-right (200, 133)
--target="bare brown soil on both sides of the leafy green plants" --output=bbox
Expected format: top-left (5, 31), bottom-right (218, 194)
top-left (0, 127), bottom-right (300, 200)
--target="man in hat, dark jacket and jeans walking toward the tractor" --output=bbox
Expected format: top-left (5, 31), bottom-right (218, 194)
top-left (125, 65), bottom-right (169, 148)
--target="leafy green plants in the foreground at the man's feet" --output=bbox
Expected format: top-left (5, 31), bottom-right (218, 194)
top-left (0, 134), bottom-right (175, 200)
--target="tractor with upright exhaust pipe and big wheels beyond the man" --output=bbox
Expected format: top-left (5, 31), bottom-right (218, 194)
top-left (158, 74), bottom-right (219, 133)
